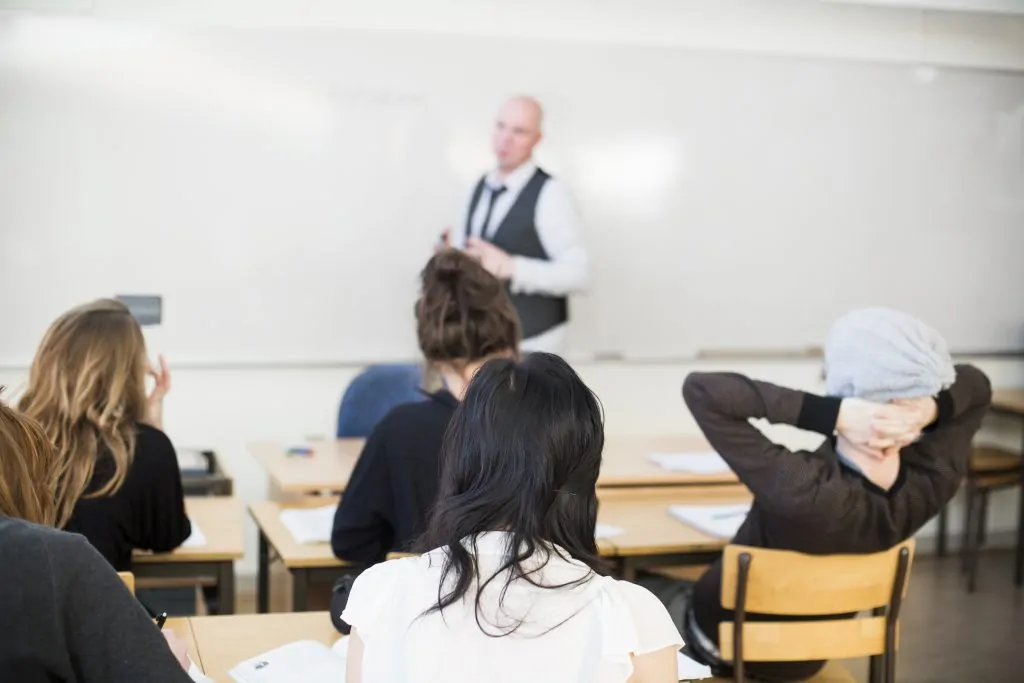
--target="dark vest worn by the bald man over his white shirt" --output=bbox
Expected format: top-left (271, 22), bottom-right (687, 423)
top-left (466, 169), bottom-right (569, 339)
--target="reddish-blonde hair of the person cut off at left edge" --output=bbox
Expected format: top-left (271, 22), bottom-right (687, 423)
top-left (0, 397), bottom-right (57, 526)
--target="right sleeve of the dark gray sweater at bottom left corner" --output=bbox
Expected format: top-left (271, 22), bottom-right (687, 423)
top-left (47, 533), bottom-right (191, 683)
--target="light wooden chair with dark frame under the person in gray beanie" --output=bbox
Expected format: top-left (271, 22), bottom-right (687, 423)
top-left (718, 539), bottom-right (914, 683)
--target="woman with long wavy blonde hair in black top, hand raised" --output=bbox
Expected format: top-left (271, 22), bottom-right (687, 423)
top-left (19, 299), bottom-right (191, 571)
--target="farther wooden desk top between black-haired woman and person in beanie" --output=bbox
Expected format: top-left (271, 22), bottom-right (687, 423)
top-left (597, 436), bottom-right (736, 486)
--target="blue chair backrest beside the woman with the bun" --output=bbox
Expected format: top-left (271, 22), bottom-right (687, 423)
top-left (336, 365), bottom-right (425, 438)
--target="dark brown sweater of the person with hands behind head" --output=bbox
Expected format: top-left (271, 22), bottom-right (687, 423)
top-left (683, 366), bottom-right (991, 681)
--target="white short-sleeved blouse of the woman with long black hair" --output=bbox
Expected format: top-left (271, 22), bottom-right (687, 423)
top-left (342, 531), bottom-right (683, 683)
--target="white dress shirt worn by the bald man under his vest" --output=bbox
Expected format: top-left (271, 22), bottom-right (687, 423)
top-left (452, 161), bottom-right (588, 353)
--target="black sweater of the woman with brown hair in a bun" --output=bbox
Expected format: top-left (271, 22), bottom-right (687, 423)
top-left (331, 390), bottom-right (459, 564)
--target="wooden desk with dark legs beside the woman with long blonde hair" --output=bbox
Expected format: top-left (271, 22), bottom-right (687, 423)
top-left (132, 497), bottom-right (245, 614)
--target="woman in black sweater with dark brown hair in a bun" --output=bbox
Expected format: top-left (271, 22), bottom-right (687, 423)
top-left (331, 249), bottom-right (520, 563)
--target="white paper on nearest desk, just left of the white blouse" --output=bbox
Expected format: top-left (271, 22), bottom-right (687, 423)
top-left (227, 638), bottom-right (348, 683)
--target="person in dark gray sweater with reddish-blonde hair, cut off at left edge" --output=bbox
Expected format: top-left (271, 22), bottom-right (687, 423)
top-left (0, 403), bottom-right (209, 683)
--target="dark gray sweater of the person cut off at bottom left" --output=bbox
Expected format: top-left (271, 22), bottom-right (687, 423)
top-left (0, 516), bottom-right (191, 683)
